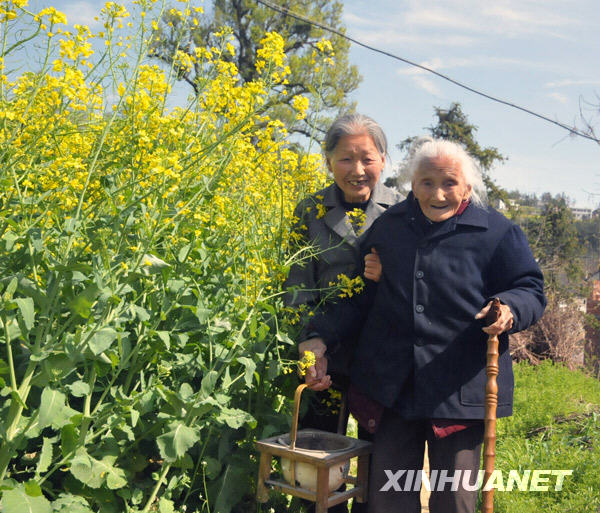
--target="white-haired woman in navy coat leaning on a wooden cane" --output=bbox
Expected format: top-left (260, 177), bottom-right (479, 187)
top-left (300, 140), bottom-right (546, 513)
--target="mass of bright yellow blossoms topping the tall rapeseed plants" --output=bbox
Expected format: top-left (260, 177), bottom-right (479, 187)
top-left (0, 1), bottom-right (325, 303)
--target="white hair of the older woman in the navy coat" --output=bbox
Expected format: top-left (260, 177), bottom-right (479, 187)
top-left (408, 138), bottom-right (487, 207)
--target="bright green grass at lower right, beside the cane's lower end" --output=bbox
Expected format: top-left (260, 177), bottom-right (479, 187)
top-left (494, 362), bottom-right (600, 513)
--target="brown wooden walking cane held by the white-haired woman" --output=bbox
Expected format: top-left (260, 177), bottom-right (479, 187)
top-left (481, 297), bottom-right (500, 513)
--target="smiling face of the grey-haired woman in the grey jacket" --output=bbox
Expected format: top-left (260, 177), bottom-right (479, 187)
top-left (327, 134), bottom-right (385, 203)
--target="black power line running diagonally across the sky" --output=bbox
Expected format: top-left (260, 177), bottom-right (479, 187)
top-left (256, 0), bottom-right (600, 144)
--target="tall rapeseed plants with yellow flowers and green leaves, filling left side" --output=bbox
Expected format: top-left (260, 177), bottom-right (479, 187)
top-left (0, 0), bottom-right (342, 513)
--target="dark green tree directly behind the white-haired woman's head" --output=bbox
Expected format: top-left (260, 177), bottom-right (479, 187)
top-left (386, 102), bottom-right (508, 204)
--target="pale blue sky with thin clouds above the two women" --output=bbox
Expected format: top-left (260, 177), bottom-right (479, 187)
top-left (31, 0), bottom-right (600, 207)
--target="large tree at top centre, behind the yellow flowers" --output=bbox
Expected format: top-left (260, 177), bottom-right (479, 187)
top-left (151, 0), bottom-right (361, 139)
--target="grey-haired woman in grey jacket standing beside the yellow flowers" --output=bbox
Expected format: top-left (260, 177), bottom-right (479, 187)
top-left (285, 114), bottom-right (401, 513)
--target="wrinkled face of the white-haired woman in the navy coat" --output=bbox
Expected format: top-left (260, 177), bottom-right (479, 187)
top-left (412, 156), bottom-right (471, 222)
